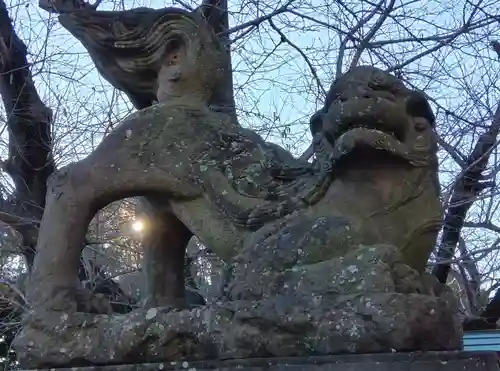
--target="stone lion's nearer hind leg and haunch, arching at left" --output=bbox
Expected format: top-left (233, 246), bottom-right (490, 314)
top-left (28, 139), bottom-right (198, 311)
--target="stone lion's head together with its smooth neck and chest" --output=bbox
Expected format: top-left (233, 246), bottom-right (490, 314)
top-left (311, 66), bottom-right (443, 271)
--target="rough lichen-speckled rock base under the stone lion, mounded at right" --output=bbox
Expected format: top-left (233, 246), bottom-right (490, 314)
top-left (16, 245), bottom-right (461, 367)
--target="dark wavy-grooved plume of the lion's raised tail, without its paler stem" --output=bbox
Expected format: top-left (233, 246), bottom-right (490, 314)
top-left (59, 8), bottom-right (226, 109)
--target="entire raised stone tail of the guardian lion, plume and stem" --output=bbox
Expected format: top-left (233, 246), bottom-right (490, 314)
top-left (59, 8), bottom-right (227, 109)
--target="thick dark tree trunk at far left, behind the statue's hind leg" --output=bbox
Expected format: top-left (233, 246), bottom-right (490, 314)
top-left (0, 0), bottom-right (55, 267)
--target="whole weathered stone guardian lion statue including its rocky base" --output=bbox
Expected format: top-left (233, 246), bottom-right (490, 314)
top-left (15, 5), bottom-right (461, 367)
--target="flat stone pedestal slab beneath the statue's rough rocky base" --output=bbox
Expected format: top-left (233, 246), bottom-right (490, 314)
top-left (20, 352), bottom-right (500, 371)
